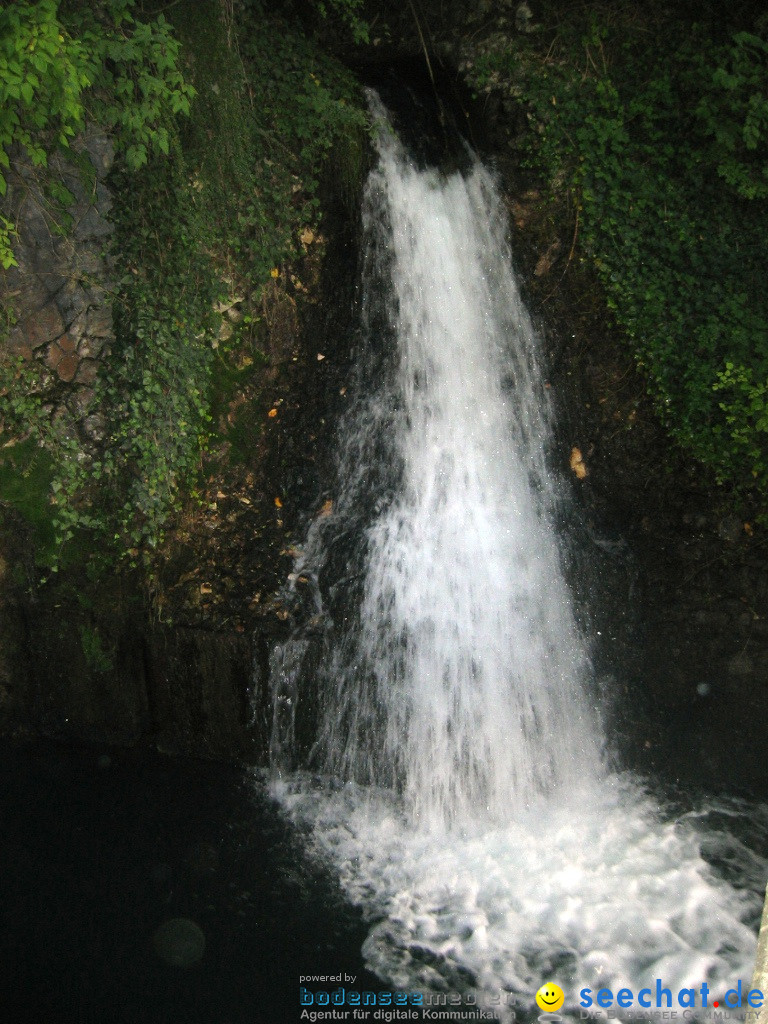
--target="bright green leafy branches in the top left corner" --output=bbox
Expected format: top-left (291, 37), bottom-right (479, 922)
top-left (0, 0), bottom-right (194, 269)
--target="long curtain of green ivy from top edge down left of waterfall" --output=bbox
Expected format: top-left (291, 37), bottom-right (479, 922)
top-left (0, 0), bottom-right (366, 569)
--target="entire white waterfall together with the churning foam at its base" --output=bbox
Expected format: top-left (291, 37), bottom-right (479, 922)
top-left (272, 96), bottom-right (763, 1006)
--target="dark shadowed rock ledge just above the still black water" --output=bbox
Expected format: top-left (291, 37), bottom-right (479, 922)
top-left (0, 515), bottom-right (263, 760)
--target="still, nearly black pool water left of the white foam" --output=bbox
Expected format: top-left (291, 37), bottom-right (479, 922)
top-left (0, 748), bottom-right (381, 1024)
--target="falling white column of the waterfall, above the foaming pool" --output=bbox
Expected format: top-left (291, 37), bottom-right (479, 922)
top-left (270, 99), bottom-right (599, 825)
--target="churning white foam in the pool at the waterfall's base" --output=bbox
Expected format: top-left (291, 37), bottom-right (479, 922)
top-left (272, 775), bottom-right (768, 1014)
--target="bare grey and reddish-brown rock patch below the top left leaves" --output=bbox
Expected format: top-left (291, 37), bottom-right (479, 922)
top-left (0, 129), bottom-right (114, 435)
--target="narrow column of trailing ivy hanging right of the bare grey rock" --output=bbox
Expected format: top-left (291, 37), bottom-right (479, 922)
top-left (47, 150), bottom-right (220, 557)
